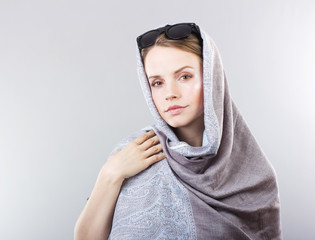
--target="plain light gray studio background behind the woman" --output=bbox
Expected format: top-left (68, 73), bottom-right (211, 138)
top-left (0, 0), bottom-right (315, 240)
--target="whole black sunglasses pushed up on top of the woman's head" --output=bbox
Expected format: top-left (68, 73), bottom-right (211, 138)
top-left (137, 23), bottom-right (202, 50)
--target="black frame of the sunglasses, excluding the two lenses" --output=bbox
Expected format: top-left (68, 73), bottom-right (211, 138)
top-left (137, 23), bottom-right (202, 51)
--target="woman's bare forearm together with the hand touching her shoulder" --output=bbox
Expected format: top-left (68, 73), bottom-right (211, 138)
top-left (74, 130), bottom-right (165, 240)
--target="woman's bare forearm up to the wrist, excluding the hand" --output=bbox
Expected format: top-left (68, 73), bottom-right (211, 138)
top-left (74, 166), bottom-right (123, 240)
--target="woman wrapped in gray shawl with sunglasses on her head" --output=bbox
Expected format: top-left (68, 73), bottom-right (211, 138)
top-left (75, 23), bottom-right (281, 240)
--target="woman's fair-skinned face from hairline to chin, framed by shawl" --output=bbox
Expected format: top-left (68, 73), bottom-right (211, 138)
top-left (144, 46), bottom-right (203, 128)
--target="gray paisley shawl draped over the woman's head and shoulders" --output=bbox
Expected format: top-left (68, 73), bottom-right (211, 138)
top-left (110, 26), bottom-right (281, 240)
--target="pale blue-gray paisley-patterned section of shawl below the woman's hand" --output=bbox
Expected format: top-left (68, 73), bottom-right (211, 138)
top-left (109, 159), bottom-right (197, 240)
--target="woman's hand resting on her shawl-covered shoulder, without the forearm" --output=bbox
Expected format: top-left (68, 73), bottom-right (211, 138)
top-left (104, 130), bottom-right (165, 179)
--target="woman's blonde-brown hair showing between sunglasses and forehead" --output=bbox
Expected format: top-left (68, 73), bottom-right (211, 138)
top-left (141, 33), bottom-right (203, 62)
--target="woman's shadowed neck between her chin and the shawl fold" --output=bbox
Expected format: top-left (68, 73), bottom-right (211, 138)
top-left (173, 116), bottom-right (204, 147)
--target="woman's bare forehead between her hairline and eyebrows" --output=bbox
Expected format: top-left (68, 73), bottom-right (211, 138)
top-left (144, 46), bottom-right (201, 75)
